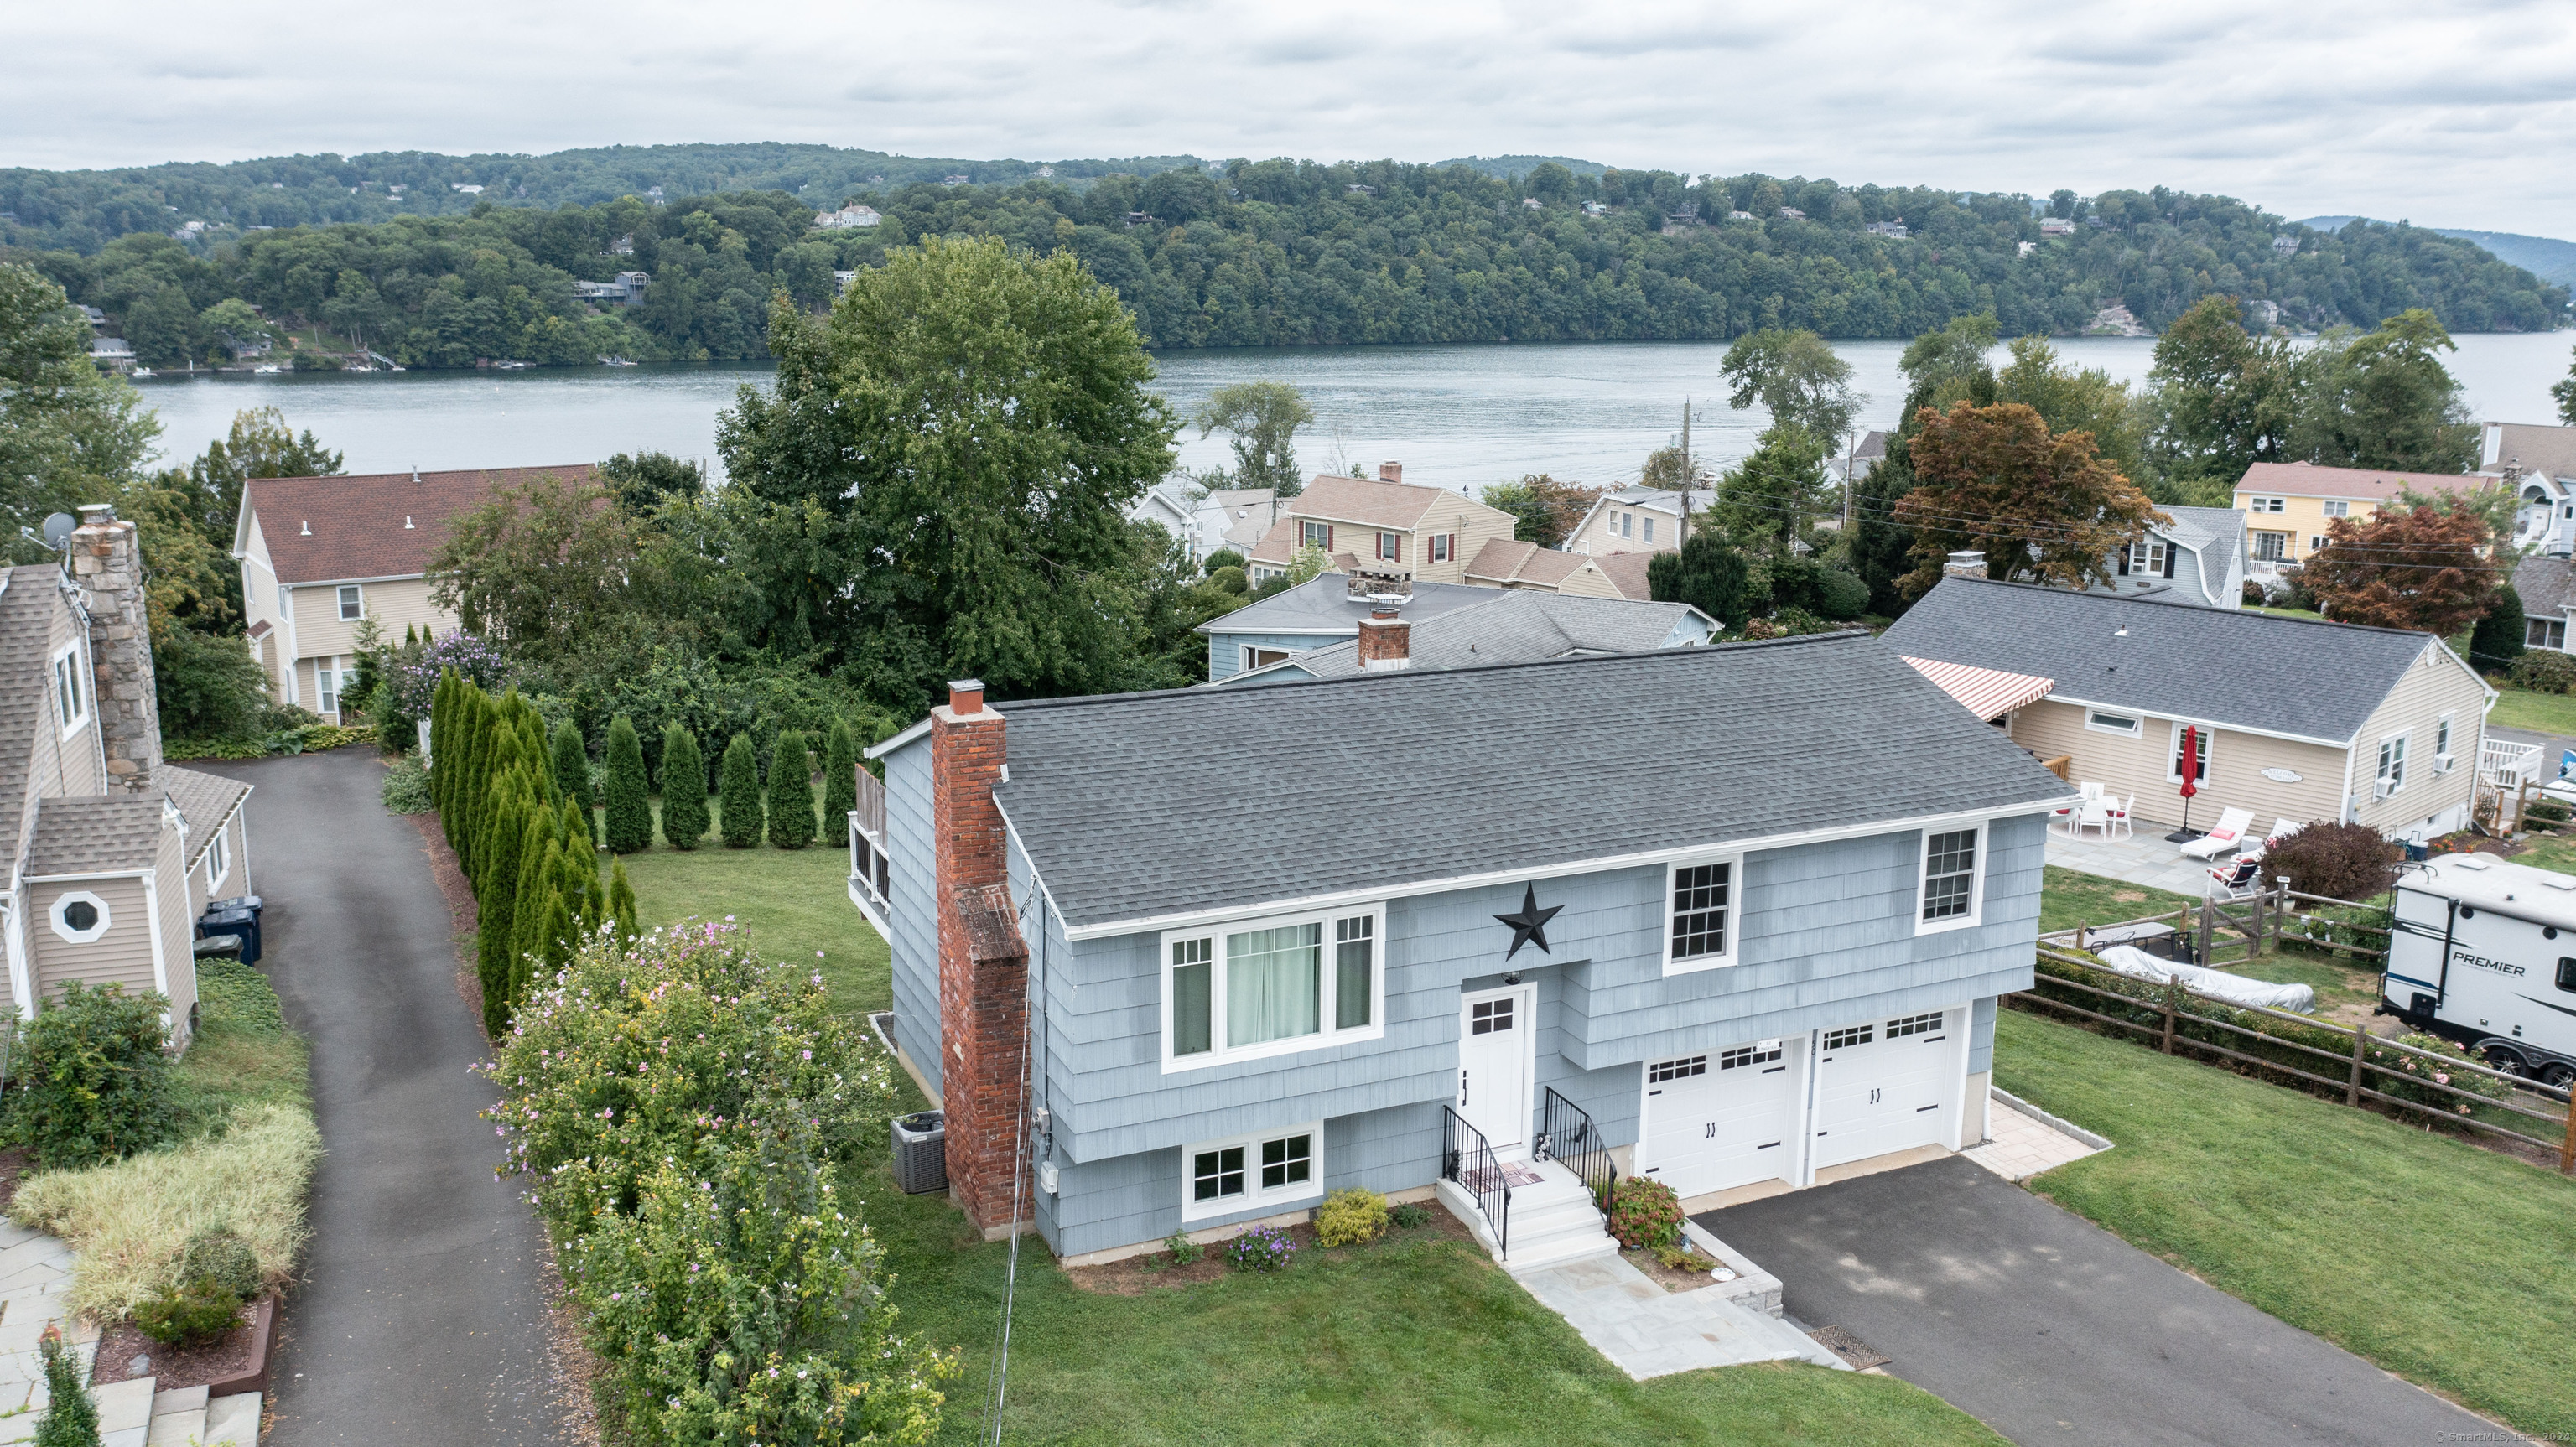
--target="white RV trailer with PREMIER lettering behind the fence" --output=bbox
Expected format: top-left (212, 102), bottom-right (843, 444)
top-left (2381, 855), bottom-right (2576, 1084)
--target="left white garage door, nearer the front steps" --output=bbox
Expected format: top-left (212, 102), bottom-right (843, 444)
top-left (1639, 1040), bottom-right (1805, 1197)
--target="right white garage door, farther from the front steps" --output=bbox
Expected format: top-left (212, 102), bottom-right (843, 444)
top-left (1816, 1009), bottom-right (1966, 1169)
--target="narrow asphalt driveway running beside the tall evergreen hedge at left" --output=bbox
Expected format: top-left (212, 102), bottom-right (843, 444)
top-left (190, 749), bottom-right (557, 1447)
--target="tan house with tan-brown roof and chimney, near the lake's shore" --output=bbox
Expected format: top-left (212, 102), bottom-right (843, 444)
top-left (1247, 464), bottom-right (1517, 584)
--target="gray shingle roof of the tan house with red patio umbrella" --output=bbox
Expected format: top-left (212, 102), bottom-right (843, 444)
top-left (1881, 577), bottom-right (2434, 744)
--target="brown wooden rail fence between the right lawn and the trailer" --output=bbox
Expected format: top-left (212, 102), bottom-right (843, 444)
top-left (2004, 950), bottom-right (2576, 1174)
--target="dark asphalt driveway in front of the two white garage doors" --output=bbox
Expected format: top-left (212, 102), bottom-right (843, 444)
top-left (1695, 1156), bottom-right (2496, 1447)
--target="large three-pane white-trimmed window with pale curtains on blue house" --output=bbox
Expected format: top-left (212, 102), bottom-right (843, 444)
top-left (1161, 906), bottom-right (1386, 1071)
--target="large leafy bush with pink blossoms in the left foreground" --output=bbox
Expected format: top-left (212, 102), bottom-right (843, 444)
top-left (490, 919), bottom-right (958, 1447)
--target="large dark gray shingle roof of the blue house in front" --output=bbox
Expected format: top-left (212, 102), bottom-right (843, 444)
top-left (984, 634), bottom-right (2066, 927)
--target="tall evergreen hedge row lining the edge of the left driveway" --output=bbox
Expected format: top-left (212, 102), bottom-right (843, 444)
top-left (430, 675), bottom-right (636, 1035)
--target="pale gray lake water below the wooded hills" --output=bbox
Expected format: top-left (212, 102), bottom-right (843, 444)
top-left (139, 332), bottom-right (2571, 486)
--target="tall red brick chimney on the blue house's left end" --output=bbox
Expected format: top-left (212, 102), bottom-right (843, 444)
top-left (930, 680), bottom-right (1031, 1236)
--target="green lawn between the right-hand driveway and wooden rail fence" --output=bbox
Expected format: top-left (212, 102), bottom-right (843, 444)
top-left (1994, 1009), bottom-right (2576, 1439)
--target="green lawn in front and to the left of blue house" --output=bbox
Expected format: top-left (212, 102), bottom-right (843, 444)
top-left (603, 842), bottom-right (2002, 1447)
